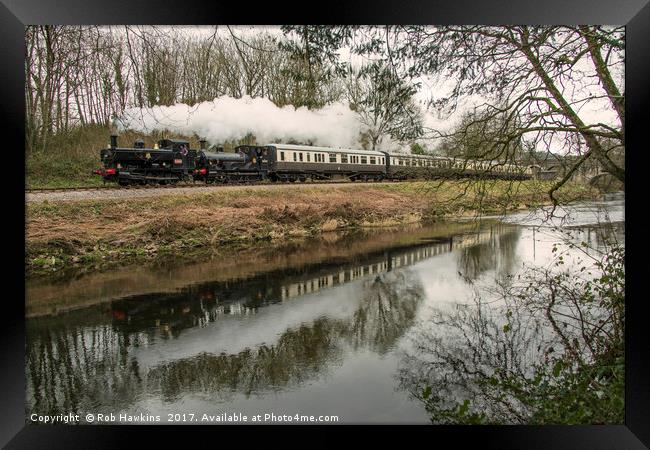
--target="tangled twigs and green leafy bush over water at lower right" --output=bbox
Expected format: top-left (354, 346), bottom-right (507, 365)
top-left (398, 237), bottom-right (625, 424)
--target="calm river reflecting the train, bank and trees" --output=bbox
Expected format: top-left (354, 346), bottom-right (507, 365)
top-left (26, 192), bottom-right (624, 423)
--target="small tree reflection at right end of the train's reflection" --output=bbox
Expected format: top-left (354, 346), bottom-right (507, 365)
top-left (458, 227), bottom-right (521, 280)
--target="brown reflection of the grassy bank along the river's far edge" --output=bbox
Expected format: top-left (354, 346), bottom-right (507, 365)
top-left (25, 223), bottom-right (496, 317)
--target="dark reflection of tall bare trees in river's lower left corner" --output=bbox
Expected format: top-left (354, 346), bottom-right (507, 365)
top-left (26, 316), bottom-right (143, 414)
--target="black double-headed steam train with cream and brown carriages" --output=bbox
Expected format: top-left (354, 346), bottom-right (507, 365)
top-left (93, 135), bottom-right (534, 186)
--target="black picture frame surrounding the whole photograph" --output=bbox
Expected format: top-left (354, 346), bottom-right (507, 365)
top-left (0, 0), bottom-right (650, 449)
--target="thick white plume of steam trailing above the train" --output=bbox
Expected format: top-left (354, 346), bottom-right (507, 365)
top-left (116, 96), bottom-right (363, 147)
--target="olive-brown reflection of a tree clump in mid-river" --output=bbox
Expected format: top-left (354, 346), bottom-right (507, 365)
top-left (147, 271), bottom-right (423, 400)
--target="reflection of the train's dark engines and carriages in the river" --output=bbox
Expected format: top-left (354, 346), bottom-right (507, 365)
top-left (111, 225), bottom-right (514, 334)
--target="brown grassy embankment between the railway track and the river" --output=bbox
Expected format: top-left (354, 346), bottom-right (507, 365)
top-left (25, 180), bottom-right (599, 276)
